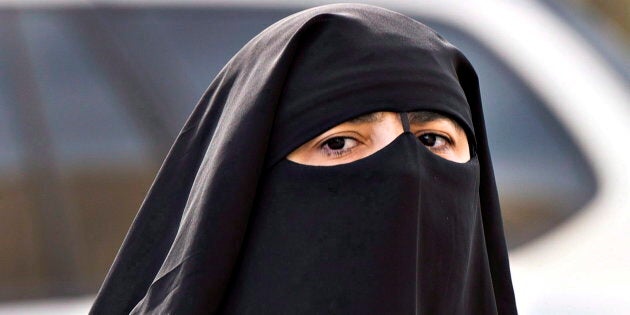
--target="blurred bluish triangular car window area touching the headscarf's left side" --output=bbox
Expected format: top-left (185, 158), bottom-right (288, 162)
top-left (100, 9), bottom-right (297, 130)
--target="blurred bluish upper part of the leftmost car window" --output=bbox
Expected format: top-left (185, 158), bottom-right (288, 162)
top-left (20, 11), bottom-right (153, 165)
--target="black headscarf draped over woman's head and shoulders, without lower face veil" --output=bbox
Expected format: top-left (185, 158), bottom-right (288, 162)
top-left (91, 4), bottom-right (516, 314)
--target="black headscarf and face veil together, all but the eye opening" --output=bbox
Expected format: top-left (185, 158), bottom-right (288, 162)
top-left (91, 4), bottom-right (516, 314)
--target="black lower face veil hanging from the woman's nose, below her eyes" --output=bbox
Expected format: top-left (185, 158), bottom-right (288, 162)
top-left (223, 133), bottom-right (496, 314)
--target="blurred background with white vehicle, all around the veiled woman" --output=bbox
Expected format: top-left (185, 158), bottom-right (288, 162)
top-left (0, 0), bottom-right (630, 314)
